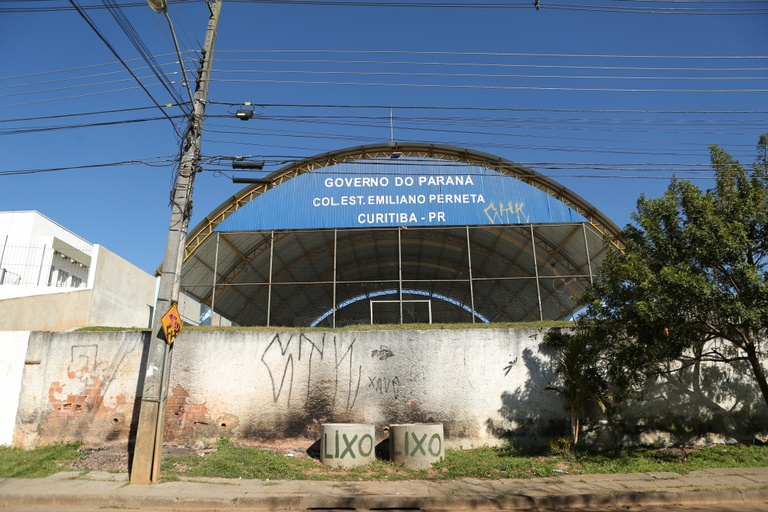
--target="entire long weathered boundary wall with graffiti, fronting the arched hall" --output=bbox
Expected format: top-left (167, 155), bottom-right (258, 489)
top-left (6, 328), bottom-right (768, 448)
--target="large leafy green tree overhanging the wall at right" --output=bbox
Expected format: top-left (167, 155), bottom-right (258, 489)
top-left (576, 135), bottom-right (768, 412)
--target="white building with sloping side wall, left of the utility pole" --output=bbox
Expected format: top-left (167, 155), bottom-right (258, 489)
top-left (0, 211), bottom-right (156, 331)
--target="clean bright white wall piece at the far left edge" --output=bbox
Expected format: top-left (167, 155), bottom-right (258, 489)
top-left (0, 332), bottom-right (29, 446)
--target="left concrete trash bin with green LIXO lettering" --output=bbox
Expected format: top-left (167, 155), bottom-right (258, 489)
top-left (320, 423), bottom-right (376, 468)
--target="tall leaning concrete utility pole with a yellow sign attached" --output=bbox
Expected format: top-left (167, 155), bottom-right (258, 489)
top-left (130, 0), bottom-right (222, 485)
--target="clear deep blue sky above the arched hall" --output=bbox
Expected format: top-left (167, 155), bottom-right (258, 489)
top-left (0, 0), bottom-right (768, 272)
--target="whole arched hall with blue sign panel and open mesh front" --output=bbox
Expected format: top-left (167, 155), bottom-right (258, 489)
top-left (181, 143), bottom-right (619, 326)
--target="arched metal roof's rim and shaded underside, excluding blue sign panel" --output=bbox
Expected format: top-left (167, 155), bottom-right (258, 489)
top-left (181, 143), bottom-right (619, 325)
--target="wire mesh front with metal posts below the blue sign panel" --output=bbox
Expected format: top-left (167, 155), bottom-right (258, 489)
top-left (195, 223), bottom-right (606, 327)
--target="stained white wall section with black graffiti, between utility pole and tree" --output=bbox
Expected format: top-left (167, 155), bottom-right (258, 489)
top-left (169, 329), bottom-right (563, 446)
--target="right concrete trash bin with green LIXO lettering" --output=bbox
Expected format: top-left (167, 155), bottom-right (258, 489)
top-left (389, 423), bottom-right (445, 469)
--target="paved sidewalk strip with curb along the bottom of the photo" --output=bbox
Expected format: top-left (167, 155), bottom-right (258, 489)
top-left (0, 468), bottom-right (768, 510)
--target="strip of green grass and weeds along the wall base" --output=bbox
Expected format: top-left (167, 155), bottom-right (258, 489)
top-left (0, 440), bottom-right (768, 481)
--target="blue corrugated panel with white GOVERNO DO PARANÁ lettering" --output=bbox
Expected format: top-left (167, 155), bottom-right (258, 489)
top-left (217, 158), bottom-right (586, 231)
